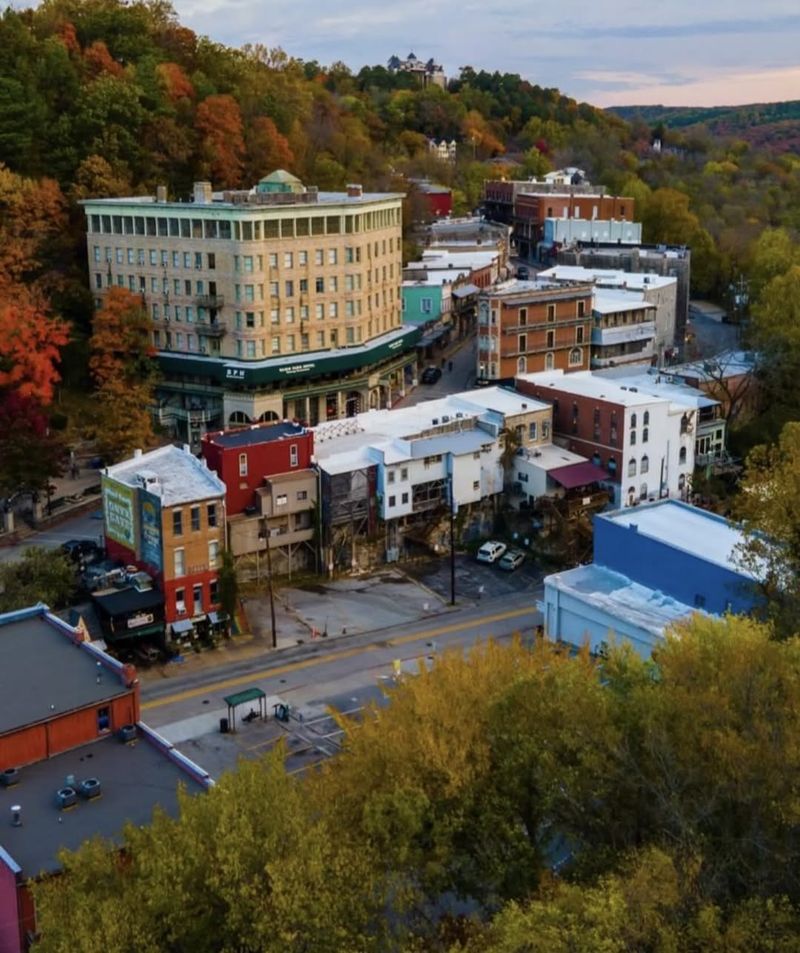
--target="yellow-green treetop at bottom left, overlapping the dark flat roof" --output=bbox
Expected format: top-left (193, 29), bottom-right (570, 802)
top-left (33, 748), bottom-right (387, 953)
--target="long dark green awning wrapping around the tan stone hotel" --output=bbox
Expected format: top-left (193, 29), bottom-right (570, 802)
top-left (153, 326), bottom-right (422, 387)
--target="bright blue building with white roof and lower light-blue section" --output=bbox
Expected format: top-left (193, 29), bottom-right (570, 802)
top-left (544, 499), bottom-right (757, 657)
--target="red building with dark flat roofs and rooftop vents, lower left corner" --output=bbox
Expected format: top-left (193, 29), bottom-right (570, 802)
top-left (0, 605), bottom-right (211, 953)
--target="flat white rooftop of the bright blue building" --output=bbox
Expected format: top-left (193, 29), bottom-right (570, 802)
top-left (597, 500), bottom-right (750, 576)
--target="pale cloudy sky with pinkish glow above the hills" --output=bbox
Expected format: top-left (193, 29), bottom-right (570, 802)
top-left (173, 0), bottom-right (800, 106)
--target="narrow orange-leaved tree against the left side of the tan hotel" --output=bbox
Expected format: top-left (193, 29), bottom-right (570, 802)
top-left (89, 287), bottom-right (158, 462)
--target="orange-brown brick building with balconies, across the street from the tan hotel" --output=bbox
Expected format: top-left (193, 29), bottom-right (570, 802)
top-left (476, 281), bottom-right (592, 380)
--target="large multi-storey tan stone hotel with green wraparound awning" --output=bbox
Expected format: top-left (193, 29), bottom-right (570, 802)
top-left (84, 172), bottom-right (419, 444)
